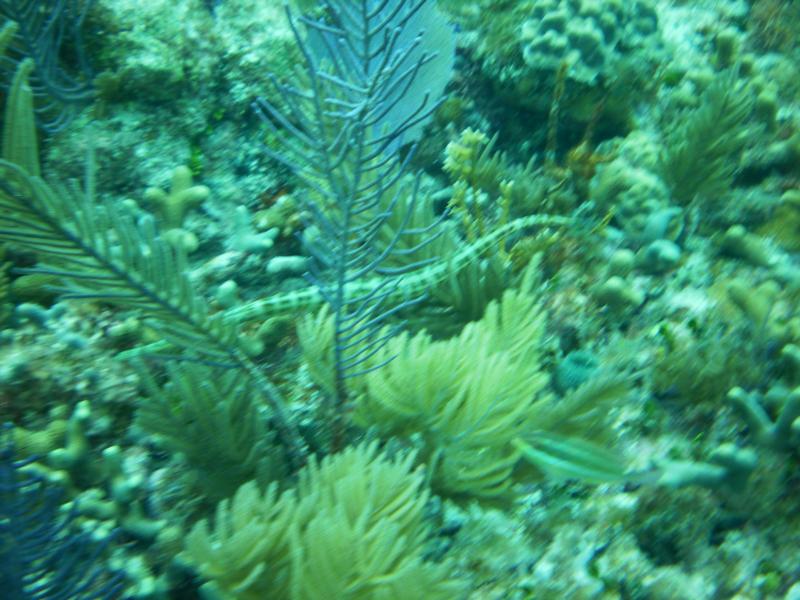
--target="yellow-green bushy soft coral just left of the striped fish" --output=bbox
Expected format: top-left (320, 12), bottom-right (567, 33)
top-left (355, 265), bottom-right (547, 498)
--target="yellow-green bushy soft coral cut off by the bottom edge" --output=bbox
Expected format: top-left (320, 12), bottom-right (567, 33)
top-left (185, 443), bottom-right (465, 600)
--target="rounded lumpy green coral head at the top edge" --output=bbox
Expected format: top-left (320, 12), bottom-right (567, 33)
top-left (450, 0), bottom-right (661, 120)
